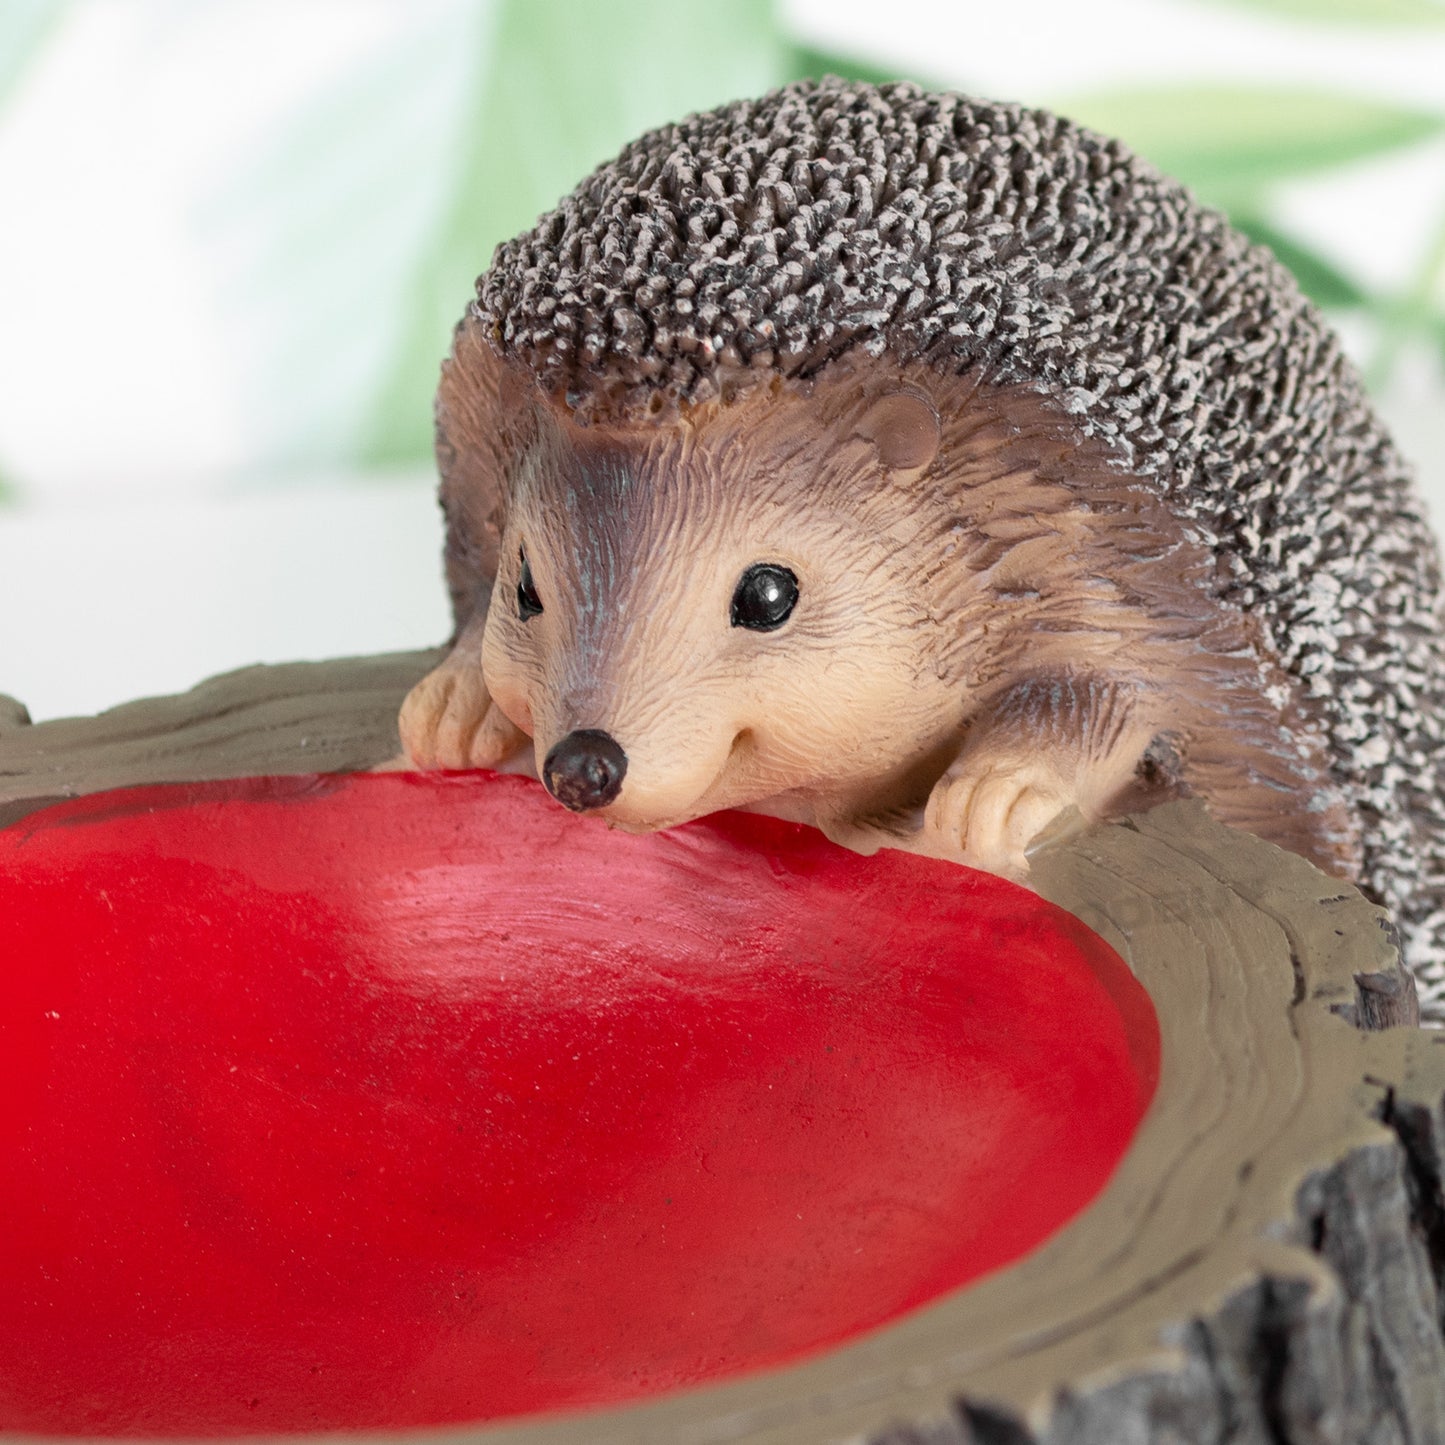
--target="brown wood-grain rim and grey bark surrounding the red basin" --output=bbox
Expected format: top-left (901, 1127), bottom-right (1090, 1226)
top-left (0, 653), bottom-right (1445, 1445)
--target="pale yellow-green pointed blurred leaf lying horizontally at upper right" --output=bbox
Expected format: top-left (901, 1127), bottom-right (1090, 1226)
top-left (1055, 85), bottom-right (1445, 197)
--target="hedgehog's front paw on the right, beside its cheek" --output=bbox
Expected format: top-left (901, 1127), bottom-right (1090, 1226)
top-left (923, 759), bottom-right (1078, 879)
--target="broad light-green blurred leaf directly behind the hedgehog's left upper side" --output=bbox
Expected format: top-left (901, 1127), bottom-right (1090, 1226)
top-left (363, 0), bottom-right (788, 464)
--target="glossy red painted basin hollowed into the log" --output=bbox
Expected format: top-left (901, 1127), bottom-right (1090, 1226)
top-left (0, 775), bottom-right (1157, 1433)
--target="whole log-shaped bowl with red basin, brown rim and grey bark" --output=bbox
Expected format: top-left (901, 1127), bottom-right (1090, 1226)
top-left (0, 656), bottom-right (1445, 1445)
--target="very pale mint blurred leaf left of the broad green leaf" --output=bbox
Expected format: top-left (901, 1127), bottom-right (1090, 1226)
top-left (195, 0), bottom-right (505, 484)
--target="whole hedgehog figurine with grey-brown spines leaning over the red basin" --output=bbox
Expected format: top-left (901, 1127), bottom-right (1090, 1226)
top-left (400, 79), bottom-right (1445, 1014)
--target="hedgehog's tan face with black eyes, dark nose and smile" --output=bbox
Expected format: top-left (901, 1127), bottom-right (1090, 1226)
top-left (483, 375), bottom-right (961, 829)
